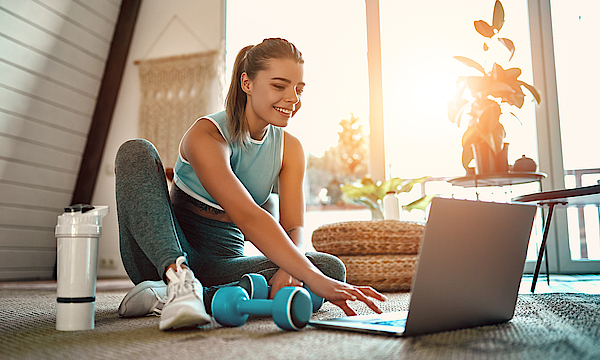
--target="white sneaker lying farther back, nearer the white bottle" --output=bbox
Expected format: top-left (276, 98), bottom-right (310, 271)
top-left (119, 280), bottom-right (167, 317)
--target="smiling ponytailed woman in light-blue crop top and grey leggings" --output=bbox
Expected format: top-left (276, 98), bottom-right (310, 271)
top-left (115, 39), bottom-right (385, 330)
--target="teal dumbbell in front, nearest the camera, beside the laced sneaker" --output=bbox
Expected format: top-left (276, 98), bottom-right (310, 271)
top-left (211, 286), bottom-right (312, 330)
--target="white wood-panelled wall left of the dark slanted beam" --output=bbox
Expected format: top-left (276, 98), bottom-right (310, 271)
top-left (0, 0), bottom-right (121, 280)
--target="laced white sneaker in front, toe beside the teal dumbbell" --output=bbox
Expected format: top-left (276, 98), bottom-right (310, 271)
top-left (159, 256), bottom-right (211, 330)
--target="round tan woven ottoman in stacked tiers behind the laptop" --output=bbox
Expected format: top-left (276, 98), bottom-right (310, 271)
top-left (312, 220), bottom-right (425, 291)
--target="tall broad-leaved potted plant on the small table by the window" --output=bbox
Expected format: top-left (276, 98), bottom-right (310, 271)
top-left (448, 0), bottom-right (540, 173)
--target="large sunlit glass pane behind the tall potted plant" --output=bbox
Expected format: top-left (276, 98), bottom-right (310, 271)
top-left (380, 0), bottom-right (542, 236)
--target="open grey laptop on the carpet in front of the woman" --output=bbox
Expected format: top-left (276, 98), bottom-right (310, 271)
top-left (309, 198), bottom-right (537, 336)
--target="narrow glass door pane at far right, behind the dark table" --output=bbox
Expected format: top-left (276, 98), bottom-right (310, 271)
top-left (550, 0), bottom-right (600, 272)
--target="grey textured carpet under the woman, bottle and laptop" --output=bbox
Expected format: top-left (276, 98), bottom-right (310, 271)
top-left (0, 289), bottom-right (600, 360)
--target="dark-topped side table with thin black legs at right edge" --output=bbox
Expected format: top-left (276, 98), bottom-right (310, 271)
top-left (512, 185), bottom-right (600, 292)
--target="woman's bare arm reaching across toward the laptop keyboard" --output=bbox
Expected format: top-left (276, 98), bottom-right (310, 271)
top-left (182, 120), bottom-right (385, 314)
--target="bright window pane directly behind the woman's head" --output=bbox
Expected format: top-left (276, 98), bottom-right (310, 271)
top-left (226, 0), bottom-right (370, 253)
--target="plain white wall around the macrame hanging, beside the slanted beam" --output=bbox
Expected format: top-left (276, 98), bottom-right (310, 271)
top-left (92, 0), bottom-right (225, 277)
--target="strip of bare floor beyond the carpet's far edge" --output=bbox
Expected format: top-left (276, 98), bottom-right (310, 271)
top-left (0, 274), bottom-right (600, 294)
